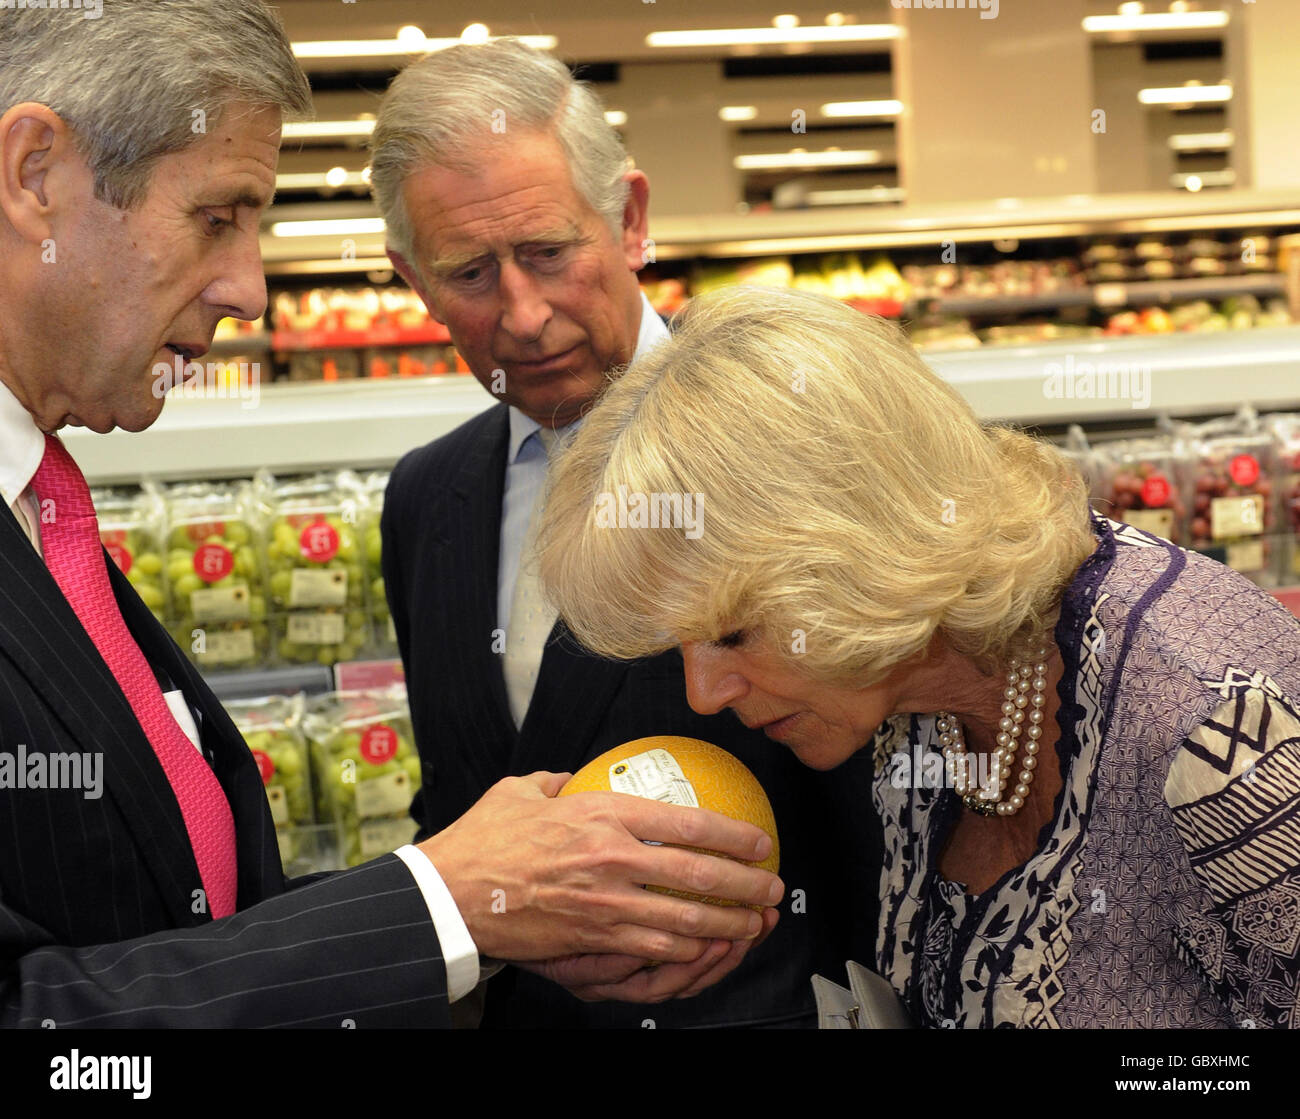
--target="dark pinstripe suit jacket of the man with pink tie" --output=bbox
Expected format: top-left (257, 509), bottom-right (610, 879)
top-left (0, 502), bottom-right (447, 1028)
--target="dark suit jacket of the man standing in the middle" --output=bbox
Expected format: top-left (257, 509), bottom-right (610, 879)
top-left (384, 404), bottom-right (880, 1028)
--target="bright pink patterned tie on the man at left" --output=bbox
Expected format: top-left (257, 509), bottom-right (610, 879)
top-left (33, 435), bottom-right (237, 918)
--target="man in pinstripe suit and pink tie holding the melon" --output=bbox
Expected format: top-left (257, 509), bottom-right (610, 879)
top-left (0, 0), bottom-right (781, 1027)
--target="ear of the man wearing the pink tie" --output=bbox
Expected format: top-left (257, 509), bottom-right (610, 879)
top-left (0, 101), bottom-right (78, 244)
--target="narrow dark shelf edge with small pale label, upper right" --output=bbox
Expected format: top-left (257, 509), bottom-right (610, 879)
top-left (906, 272), bottom-right (1286, 317)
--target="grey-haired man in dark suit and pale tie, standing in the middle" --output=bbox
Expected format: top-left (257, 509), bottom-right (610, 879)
top-left (371, 40), bottom-right (880, 1028)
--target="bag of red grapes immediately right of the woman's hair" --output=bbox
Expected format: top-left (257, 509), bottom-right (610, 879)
top-left (1093, 435), bottom-right (1188, 547)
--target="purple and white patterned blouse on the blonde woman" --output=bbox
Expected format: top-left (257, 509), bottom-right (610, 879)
top-left (872, 516), bottom-right (1300, 1028)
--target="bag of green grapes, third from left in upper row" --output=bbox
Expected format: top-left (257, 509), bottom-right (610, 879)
top-left (267, 477), bottom-right (369, 665)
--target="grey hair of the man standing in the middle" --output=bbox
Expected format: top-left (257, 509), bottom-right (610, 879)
top-left (371, 38), bottom-right (628, 264)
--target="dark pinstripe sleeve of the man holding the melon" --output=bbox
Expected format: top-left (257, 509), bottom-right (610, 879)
top-left (0, 855), bottom-right (449, 1028)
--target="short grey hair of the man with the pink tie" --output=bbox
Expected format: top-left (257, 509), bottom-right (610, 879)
top-left (0, 0), bottom-right (312, 209)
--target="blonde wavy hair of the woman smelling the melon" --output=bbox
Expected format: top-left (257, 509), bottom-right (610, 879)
top-left (538, 287), bottom-right (1095, 686)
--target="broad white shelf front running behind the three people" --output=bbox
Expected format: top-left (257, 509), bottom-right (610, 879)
top-left (68, 326), bottom-right (1300, 483)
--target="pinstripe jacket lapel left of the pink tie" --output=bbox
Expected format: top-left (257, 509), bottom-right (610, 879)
top-left (0, 502), bottom-right (203, 927)
